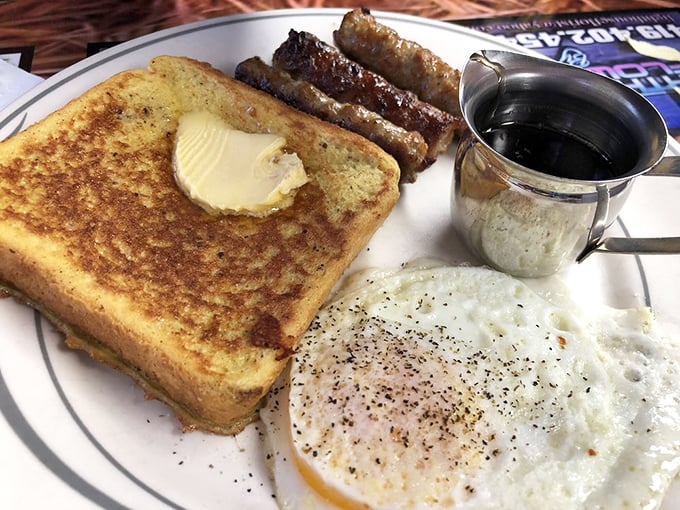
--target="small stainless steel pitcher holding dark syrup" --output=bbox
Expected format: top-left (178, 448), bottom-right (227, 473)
top-left (451, 51), bottom-right (680, 277)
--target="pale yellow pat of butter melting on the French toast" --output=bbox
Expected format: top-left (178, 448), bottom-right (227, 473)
top-left (173, 111), bottom-right (308, 216)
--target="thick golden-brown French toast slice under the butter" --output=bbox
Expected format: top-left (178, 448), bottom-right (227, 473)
top-left (0, 56), bottom-right (399, 434)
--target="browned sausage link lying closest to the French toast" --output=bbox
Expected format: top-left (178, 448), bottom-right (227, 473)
top-left (234, 57), bottom-right (427, 182)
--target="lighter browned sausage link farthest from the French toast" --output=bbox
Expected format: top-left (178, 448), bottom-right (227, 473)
top-left (333, 9), bottom-right (461, 121)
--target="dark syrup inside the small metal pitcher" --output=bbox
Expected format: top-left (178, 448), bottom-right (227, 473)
top-left (482, 123), bottom-right (620, 181)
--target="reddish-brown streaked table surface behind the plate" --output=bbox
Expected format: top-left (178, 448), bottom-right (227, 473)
top-left (0, 0), bottom-right (679, 77)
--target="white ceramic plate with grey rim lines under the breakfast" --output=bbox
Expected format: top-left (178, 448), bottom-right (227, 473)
top-left (0, 9), bottom-right (680, 510)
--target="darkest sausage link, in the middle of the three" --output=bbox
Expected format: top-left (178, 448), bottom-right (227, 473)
top-left (273, 30), bottom-right (456, 161)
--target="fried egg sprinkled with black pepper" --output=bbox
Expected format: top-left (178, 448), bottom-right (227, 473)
top-left (261, 266), bottom-right (680, 509)
